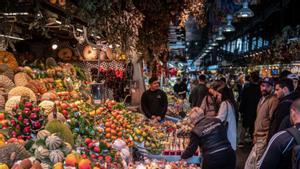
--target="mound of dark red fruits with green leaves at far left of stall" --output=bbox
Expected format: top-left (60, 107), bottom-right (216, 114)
top-left (9, 97), bottom-right (45, 140)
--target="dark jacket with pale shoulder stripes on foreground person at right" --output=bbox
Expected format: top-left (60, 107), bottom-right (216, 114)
top-left (258, 124), bottom-right (300, 169)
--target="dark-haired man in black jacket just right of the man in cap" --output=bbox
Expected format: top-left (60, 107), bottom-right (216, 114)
top-left (269, 79), bottom-right (299, 138)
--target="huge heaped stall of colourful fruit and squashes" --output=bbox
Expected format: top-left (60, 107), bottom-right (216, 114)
top-left (0, 52), bottom-right (200, 169)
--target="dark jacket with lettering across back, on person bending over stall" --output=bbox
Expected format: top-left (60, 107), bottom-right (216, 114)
top-left (181, 118), bottom-right (232, 159)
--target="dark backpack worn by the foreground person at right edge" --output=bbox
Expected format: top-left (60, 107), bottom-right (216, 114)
top-left (287, 127), bottom-right (300, 169)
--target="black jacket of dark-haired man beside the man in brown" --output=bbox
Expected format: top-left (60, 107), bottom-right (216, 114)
top-left (269, 92), bottom-right (300, 138)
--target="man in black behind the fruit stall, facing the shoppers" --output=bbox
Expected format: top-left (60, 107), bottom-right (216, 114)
top-left (141, 77), bottom-right (168, 120)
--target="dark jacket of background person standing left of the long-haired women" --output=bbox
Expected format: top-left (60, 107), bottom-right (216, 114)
top-left (189, 84), bottom-right (208, 108)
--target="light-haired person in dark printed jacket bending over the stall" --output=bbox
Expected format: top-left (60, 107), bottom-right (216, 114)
top-left (181, 108), bottom-right (236, 169)
